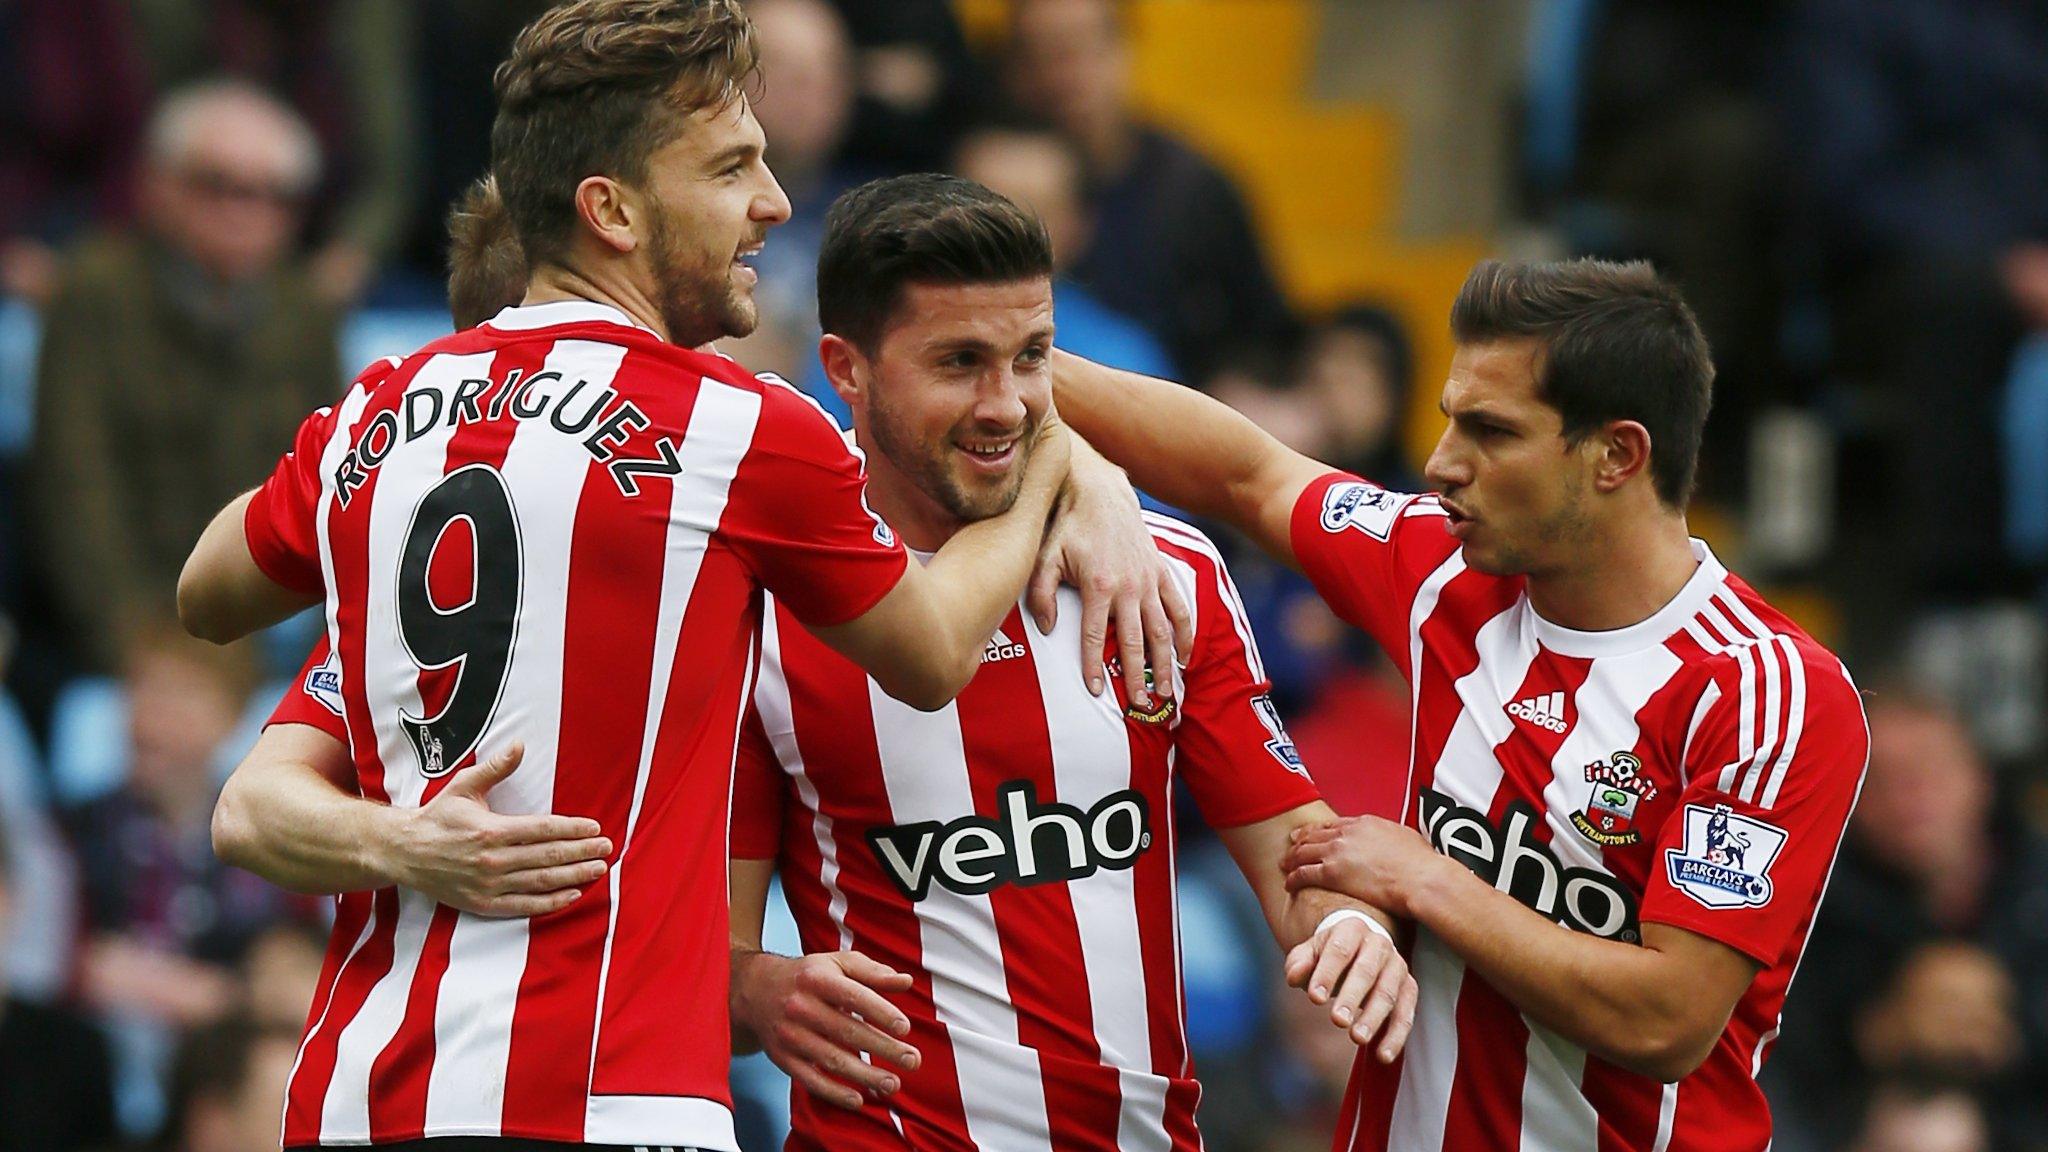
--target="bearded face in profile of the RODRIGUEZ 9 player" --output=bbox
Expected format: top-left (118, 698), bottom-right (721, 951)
top-left (641, 96), bottom-right (788, 346)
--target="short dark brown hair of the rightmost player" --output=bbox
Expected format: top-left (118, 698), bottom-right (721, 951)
top-left (1450, 258), bottom-right (1714, 508)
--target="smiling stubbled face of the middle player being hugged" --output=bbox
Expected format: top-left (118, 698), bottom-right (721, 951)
top-left (827, 279), bottom-right (1053, 547)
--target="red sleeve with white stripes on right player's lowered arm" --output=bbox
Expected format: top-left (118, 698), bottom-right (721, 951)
top-left (1642, 635), bottom-right (1870, 968)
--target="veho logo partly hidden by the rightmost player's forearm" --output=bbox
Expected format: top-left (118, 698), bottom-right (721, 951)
top-left (1421, 787), bottom-right (1642, 943)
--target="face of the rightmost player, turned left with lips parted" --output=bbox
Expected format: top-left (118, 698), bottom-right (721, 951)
top-left (1423, 340), bottom-right (1595, 576)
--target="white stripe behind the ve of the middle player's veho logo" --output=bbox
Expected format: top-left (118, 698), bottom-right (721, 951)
top-left (868, 676), bottom-right (1071, 1152)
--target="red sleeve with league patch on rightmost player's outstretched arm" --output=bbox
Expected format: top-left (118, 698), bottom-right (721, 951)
top-left (1288, 471), bottom-right (1458, 672)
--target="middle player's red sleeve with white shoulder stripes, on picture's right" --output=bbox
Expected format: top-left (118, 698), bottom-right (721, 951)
top-left (1161, 527), bottom-right (1319, 828)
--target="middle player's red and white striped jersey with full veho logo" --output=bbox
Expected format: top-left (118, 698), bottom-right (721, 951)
top-left (733, 519), bottom-right (1317, 1152)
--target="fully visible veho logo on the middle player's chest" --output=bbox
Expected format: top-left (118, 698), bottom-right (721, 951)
top-left (868, 781), bottom-right (1151, 900)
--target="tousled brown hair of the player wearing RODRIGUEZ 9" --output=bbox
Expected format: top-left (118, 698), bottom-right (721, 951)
top-left (492, 0), bottom-right (756, 264)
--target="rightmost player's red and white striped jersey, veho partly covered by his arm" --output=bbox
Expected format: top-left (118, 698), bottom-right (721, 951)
top-left (1290, 474), bottom-right (1870, 1152)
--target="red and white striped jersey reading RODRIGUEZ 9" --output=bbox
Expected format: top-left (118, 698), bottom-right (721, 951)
top-left (246, 301), bottom-right (907, 1148)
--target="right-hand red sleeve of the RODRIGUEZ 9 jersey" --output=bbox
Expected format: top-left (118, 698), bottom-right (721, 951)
top-left (719, 381), bottom-right (909, 627)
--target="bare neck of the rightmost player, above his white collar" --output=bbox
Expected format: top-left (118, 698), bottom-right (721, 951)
top-left (1528, 512), bottom-right (1700, 631)
